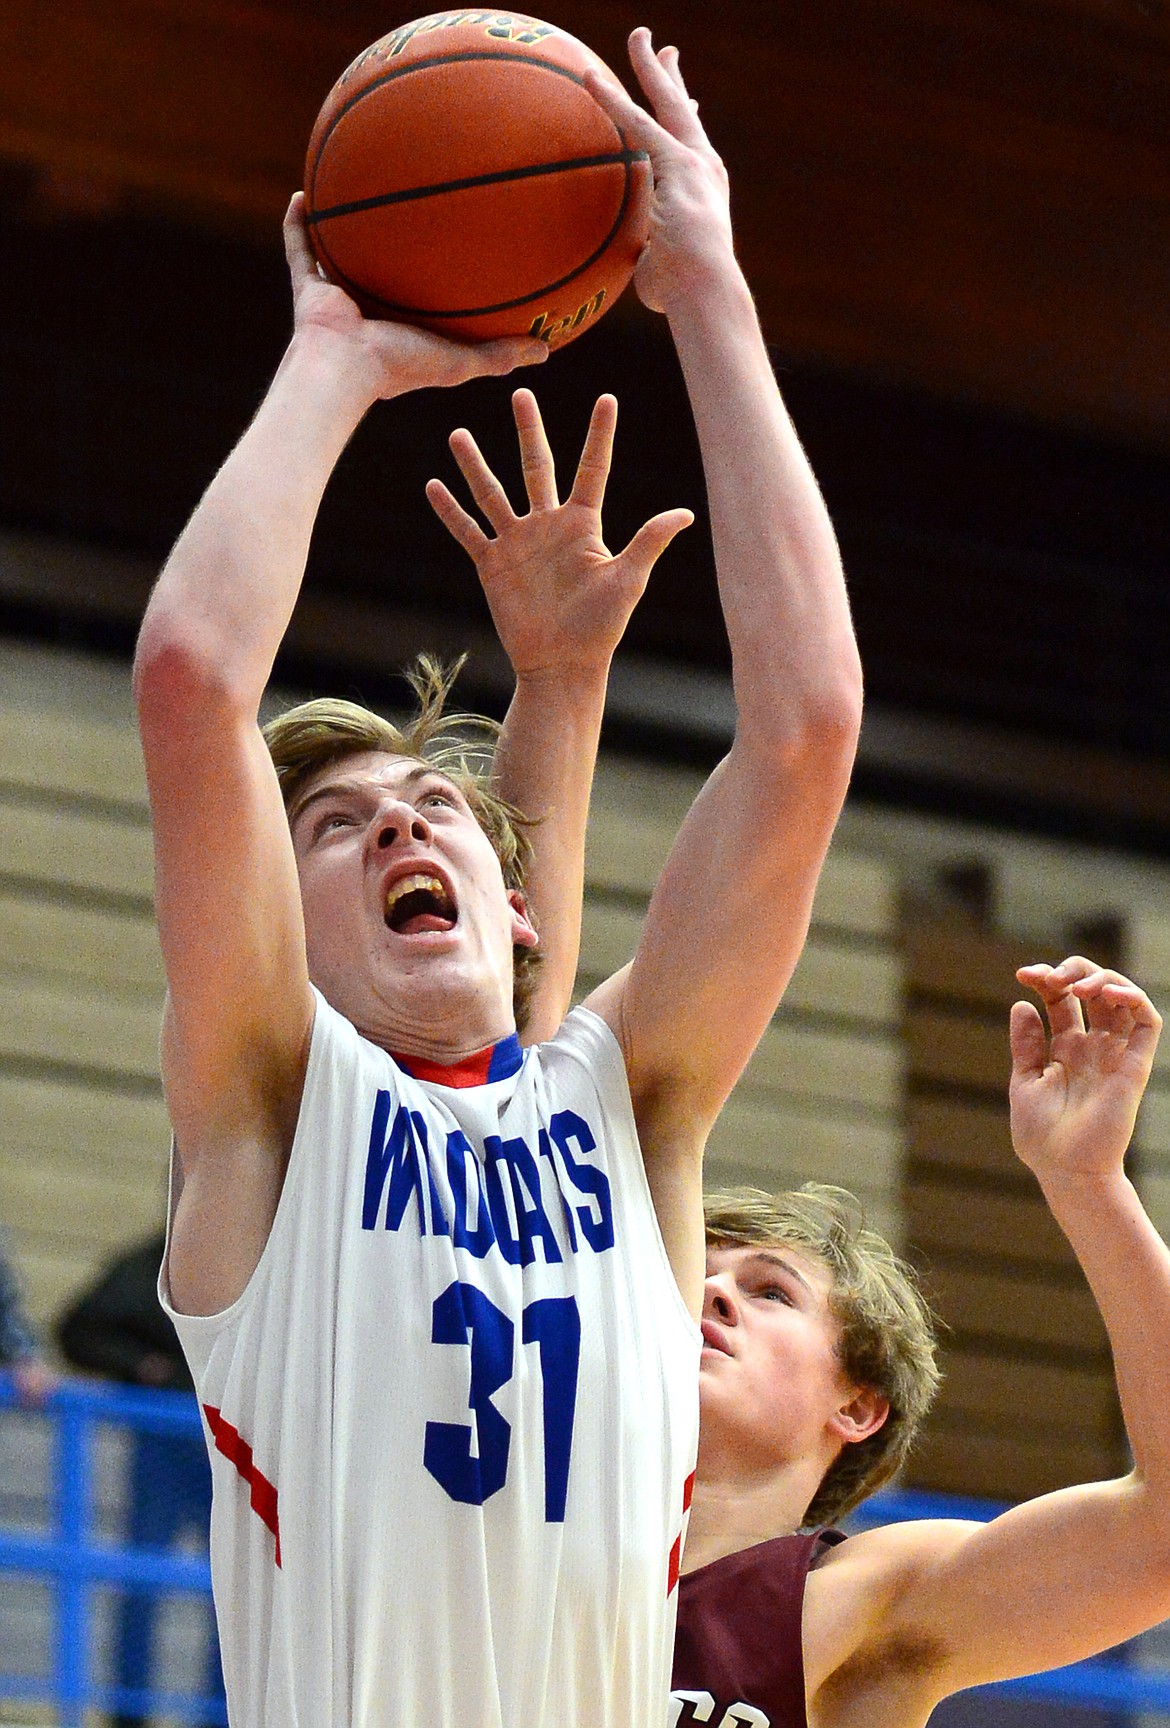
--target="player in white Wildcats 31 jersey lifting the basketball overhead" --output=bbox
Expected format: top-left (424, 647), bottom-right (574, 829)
top-left (135, 31), bottom-right (861, 1728)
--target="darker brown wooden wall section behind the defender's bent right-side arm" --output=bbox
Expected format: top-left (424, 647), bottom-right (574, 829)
top-left (904, 902), bottom-right (1125, 1500)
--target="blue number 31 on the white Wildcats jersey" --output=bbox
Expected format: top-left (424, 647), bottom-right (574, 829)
top-left (423, 1279), bottom-right (581, 1524)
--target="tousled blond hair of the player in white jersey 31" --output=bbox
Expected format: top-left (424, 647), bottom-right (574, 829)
top-left (264, 655), bottom-right (543, 1032)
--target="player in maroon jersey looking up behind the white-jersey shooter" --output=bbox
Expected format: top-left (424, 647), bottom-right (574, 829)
top-left (671, 956), bottom-right (1170, 1728)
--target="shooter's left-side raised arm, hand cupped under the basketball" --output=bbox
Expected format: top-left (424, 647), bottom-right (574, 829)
top-left (135, 197), bottom-right (541, 1306)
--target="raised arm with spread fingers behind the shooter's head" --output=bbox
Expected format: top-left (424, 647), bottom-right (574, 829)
top-left (427, 391), bottom-right (693, 1044)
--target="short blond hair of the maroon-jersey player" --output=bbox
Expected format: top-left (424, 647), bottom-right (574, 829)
top-left (703, 1182), bottom-right (942, 1526)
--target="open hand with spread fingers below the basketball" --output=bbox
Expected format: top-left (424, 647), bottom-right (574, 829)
top-left (427, 391), bottom-right (695, 677)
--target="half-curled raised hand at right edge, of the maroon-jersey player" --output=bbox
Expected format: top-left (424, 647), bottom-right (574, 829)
top-left (1009, 954), bottom-right (1161, 1178)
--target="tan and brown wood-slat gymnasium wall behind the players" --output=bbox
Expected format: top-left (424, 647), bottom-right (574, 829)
top-left (0, 645), bottom-right (1170, 1496)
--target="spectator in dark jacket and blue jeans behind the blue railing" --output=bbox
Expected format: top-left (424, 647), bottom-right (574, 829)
top-left (57, 1230), bottom-right (225, 1728)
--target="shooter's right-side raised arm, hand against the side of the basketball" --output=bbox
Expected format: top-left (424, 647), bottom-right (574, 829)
top-left (588, 31), bottom-right (861, 1299)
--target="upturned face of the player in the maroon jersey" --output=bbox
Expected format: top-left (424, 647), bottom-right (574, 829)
top-left (700, 1246), bottom-right (852, 1474)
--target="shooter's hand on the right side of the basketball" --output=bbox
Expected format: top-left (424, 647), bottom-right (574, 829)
top-left (584, 28), bottom-right (734, 313)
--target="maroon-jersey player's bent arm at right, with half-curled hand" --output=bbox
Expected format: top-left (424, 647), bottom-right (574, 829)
top-left (815, 956), bottom-right (1170, 1697)
